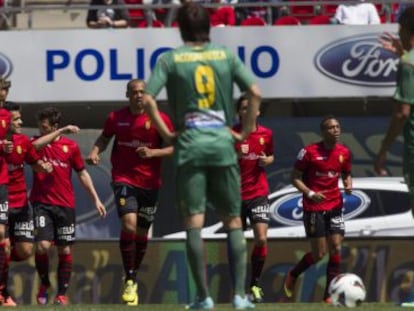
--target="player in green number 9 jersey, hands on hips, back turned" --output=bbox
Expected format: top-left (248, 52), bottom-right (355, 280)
top-left (144, 2), bottom-right (261, 310)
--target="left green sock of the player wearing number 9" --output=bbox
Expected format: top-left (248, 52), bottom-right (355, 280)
top-left (186, 229), bottom-right (209, 299)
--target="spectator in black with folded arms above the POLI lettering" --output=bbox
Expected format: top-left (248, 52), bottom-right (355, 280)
top-left (86, 0), bottom-right (129, 28)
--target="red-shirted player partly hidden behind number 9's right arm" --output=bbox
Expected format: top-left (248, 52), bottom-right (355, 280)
top-left (233, 95), bottom-right (274, 302)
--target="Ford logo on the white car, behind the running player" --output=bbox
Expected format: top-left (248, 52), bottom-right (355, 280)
top-left (270, 190), bottom-right (371, 226)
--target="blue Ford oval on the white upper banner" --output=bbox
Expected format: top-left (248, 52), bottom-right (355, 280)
top-left (315, 34), bottom-right (399, 87)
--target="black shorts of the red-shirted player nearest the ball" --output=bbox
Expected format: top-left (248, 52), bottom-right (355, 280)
top-left (303, 208), bottom-right (345, 238)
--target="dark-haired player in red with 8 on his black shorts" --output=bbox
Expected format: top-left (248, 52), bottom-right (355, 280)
top-left (30, 107), bottom-right (106, 305)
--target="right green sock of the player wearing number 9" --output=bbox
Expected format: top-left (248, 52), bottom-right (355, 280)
top-left (227, 228), bottom-right (247, 297)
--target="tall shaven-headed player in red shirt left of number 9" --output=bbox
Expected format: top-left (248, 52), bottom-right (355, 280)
top-left (87, 79), bottom-right (173, 305)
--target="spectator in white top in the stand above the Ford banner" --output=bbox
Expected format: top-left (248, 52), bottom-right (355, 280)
top-left (332, 0), bottom-right (381, 25)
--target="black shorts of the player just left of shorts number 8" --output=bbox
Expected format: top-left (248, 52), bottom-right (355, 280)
top-left (9, 206), bottom-right (34, 242)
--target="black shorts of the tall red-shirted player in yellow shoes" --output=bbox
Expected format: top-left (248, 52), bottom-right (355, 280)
top-left (112, 183), bottom-right (158, 229)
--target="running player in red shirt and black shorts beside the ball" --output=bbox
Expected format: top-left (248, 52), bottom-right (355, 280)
top-left (284, 115), bottom-right (352, 303)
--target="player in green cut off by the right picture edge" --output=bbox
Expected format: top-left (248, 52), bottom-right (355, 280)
top-left (374, 7), bottom-right (414, 306)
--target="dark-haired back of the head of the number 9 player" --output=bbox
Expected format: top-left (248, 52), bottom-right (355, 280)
top-left (177, 2), bottom-right (210, 42)
